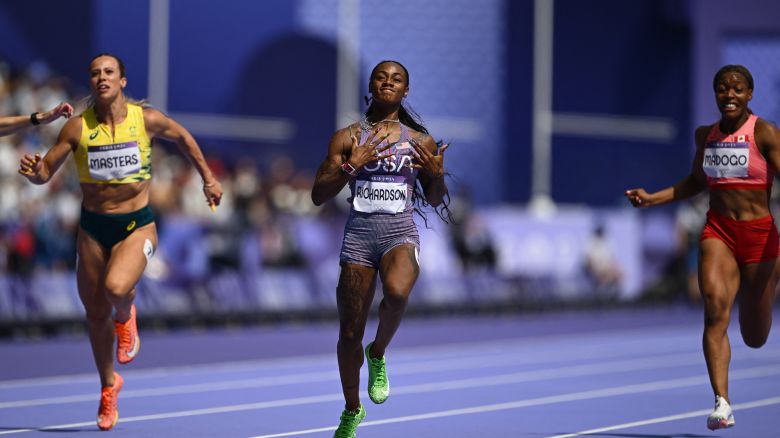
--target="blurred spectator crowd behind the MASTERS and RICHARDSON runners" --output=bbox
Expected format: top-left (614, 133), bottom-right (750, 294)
top-left (0, 60), bottom-right (496, 283)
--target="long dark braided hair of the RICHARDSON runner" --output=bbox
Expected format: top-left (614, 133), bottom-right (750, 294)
top-left (361, 60), bottom-right (453, 228)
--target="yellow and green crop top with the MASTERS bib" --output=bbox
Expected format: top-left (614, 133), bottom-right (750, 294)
top-left (73, 104), bottom-right (152, 184)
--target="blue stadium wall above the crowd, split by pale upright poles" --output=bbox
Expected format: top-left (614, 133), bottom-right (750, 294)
top-left (0, 0), bottom-right (692, 206)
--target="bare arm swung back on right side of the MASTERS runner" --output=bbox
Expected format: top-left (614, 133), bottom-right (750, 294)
top-left (144, 108), bottom-right (222, 206)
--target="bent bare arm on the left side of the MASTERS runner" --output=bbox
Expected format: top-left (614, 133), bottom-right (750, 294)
top-left (19, 118), bottom-right (81, 184)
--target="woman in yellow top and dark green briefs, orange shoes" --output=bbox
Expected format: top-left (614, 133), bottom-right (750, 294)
top-left (19, 54), bottom-right (222, 430)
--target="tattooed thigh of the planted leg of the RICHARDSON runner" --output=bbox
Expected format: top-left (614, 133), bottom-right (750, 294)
top-left (336, 263), bottom-right (376, 324)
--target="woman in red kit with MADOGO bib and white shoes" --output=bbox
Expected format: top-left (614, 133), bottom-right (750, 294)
top-left (626, 65), bottom-right (780, 430)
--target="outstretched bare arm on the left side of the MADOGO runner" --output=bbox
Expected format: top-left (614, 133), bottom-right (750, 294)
top-left (626, 126), bottom-right (710, 207)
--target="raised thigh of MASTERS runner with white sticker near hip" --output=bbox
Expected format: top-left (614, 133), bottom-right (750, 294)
top-left (106, 223), bottom-right (157, 290)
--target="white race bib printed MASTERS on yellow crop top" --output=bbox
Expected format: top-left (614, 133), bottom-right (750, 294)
top-left (88, 141), bottom-right (141, 181)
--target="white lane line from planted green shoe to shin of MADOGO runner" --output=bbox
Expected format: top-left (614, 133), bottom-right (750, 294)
top-left (247, 366), bottom-right (780, 438)
